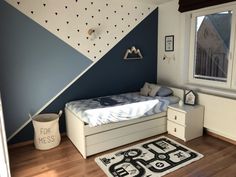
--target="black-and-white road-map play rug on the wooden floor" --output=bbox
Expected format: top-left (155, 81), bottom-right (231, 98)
top-left (95, 136), bottom-right (203, 177)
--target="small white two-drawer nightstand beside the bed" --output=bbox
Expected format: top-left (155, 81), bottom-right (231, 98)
top-left (167, 104), bottom-right (204, 141)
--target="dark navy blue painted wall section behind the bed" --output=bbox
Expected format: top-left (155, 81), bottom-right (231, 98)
top-left (11, 10), bottom-right (158, 143)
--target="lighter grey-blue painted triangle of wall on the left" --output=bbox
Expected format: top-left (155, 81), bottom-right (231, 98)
top-left (0, 1), bottom-right (92, 137)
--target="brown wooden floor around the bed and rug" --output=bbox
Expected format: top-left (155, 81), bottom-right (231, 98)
top-left (9, 135), bottom-right (236, 177)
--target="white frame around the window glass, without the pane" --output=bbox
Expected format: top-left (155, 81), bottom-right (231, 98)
top-left (188, 3), bottom-right (236, 89)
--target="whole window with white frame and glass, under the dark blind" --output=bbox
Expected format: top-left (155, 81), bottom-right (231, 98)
top-left (189, 5), bottom-right (236, 88)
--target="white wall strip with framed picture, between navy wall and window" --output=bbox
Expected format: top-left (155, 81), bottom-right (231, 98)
top-left (157, 0), bottom-right (183, 85)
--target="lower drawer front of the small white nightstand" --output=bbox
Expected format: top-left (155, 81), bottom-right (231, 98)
top-left (167, 120), bottom-right (185, 140)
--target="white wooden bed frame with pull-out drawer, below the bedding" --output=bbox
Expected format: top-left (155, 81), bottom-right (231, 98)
top-left (65, 89), bottom-right (182, 158)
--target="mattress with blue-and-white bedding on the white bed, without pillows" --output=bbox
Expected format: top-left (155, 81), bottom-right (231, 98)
top-left (66, 92), bottom-right (179, 127)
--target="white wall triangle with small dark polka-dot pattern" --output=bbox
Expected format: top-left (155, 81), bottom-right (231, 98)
top-left (6, 0), bottom-right (157, 61)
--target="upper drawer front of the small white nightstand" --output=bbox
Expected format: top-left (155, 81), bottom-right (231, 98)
top-left (167, 108), bottom-right (186, 125)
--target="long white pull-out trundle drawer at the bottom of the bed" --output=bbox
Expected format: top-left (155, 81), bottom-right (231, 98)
top-left (86, 117), bottom-right (167, 156)
